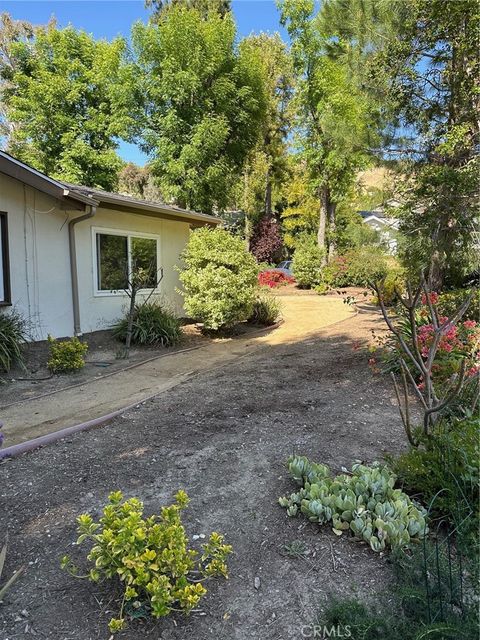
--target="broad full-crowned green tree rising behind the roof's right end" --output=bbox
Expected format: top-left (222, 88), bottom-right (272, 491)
top-left (132, 7), bottom-right (266, 212)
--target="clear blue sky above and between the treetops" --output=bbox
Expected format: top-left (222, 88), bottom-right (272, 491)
top-left (1, 0), bottom-right (287, 165)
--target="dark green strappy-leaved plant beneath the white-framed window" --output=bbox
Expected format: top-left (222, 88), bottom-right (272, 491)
top-left (112, 302), bottom-right (183, 347)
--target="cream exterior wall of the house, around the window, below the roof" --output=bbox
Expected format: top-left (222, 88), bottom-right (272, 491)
top-left (0, 173), bottom-right (190, 340)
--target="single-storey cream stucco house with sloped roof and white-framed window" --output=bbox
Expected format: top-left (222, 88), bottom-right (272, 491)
top-left (0, 151), bottom-right (221, 340)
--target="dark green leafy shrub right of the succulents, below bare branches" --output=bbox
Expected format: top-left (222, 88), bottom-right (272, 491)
top-left (390, 418), bottom-right (480, 528)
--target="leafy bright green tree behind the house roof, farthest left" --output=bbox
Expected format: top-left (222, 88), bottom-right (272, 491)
top-left (0, 19), bottom-right (133, 189)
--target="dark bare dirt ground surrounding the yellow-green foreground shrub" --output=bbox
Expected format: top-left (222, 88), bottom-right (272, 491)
top-left (0, 304), bottom-right (405, 640)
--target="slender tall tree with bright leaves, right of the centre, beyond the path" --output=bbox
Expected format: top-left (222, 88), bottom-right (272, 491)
top-left (280, 0), bottom-right (374, 256)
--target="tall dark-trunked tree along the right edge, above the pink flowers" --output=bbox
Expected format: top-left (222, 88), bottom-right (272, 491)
top-left (324, 0), bottom-right (480, 288)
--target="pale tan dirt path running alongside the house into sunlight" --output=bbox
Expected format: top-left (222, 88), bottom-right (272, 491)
top-left (0, 292), bottom-right (351, 446)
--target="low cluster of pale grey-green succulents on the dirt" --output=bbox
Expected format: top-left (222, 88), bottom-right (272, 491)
top-left (279, 456), bottom-right (428, 551)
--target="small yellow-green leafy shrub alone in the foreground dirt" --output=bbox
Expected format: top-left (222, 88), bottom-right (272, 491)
top-left (61, 491), bottom-right (232, 633)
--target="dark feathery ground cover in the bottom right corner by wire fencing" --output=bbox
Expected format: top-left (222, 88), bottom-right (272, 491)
top-left (314, 543), bottom-right (479, 640)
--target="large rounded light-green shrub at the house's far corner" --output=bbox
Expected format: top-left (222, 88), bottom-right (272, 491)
top-left (180, 227), bottom-right (258, 331)
